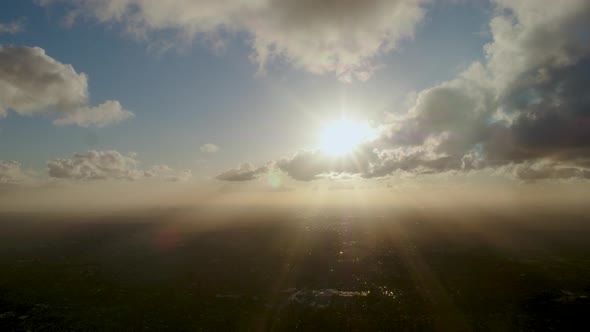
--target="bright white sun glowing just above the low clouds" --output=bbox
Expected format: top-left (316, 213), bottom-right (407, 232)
top-left (320, 119), bottom-right (375, 156)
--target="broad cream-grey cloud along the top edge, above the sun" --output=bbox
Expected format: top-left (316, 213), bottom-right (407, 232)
top-left (37, 0), bottom-right (429, 81)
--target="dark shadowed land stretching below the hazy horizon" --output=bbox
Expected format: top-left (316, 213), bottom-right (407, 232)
top-left (0, 209), bottom-right (590, 331)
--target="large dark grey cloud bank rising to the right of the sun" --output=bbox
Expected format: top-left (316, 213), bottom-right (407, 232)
top-left (223, 0), bottom-right (590, 181)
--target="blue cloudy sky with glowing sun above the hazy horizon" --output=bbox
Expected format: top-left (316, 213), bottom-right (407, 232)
top-left (0, 0), bottom-right (590, 210)
